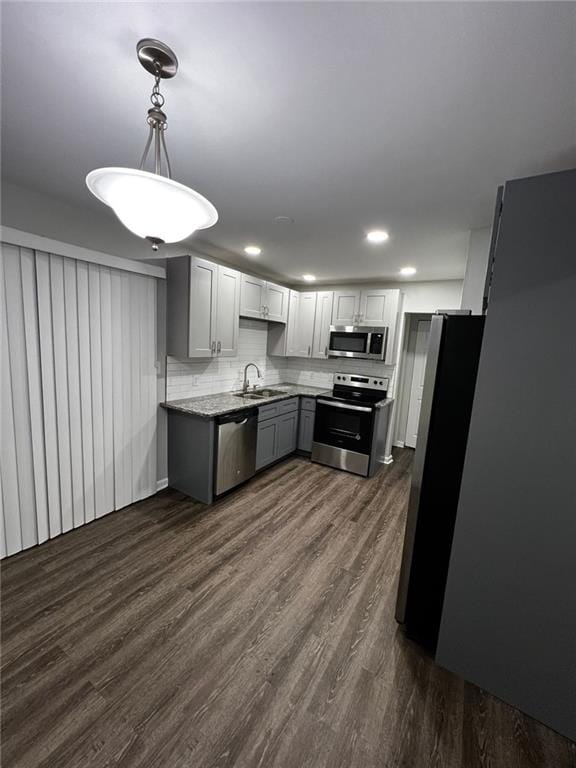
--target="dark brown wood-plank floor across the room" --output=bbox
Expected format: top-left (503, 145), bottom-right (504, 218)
top-left (2, 451), bottom-right (576, 768)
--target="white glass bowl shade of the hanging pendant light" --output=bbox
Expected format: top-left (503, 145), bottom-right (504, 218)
top-left (86, 168), bottom-right (218, 243)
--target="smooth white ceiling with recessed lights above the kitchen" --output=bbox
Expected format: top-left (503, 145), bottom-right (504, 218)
top-left (2, 2), bottom-right (576, 282)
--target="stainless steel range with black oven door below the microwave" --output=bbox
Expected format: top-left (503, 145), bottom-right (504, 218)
top-left (312, 373), bottom-right (391, 477)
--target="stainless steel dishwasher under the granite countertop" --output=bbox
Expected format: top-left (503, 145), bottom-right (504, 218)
top-left (214, 408), bottom-right (258, 496)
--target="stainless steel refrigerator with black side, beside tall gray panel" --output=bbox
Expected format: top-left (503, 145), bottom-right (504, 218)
top-left (396, 311), bottom-right (485, 653)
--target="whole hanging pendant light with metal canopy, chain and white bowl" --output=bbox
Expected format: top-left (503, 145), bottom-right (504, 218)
top-left (86, 38), bottom-right (218, 251)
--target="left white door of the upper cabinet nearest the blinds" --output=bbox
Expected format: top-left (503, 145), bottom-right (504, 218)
top-left (188, 256), bottom-right (218, 357)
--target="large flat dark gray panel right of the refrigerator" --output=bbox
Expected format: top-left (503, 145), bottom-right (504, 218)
top-left (437, 171), bottom-right (576, 739)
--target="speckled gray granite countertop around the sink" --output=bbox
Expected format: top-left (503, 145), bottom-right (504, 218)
top-left (162, 384), bottom-right (331, 419)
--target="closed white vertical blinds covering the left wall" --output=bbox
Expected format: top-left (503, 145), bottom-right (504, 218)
top-left (0, 243), bottom-right (157, 557)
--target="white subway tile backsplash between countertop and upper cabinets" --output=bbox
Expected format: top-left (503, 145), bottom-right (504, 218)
top-left (166, 318), bottom-right (394, 400)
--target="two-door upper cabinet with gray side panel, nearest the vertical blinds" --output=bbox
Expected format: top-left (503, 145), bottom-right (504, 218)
top-left (166, 256), bottom-right (240, 359)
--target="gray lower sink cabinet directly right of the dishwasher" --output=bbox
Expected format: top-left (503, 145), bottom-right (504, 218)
top-left (256, 397), bottom-right (298, 469)
